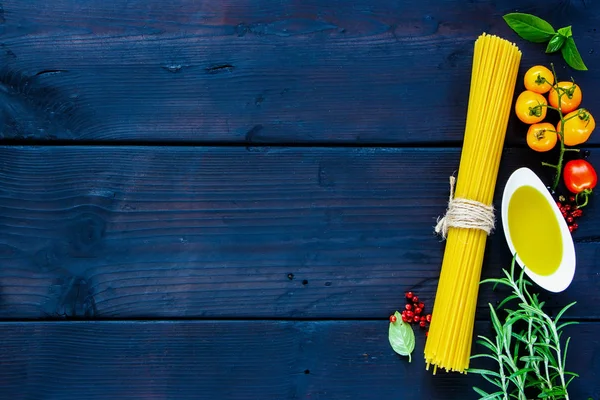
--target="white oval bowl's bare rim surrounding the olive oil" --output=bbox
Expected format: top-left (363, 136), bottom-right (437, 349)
top-left (502, 168), bottom-right (575, 293)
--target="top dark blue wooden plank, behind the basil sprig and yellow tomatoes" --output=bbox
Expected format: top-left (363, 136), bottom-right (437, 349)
top-left (0, 0), bottom-right (600, 144)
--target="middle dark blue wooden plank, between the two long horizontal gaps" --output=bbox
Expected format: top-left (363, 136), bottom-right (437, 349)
top-left (0, 147), bottom-right (600, 318)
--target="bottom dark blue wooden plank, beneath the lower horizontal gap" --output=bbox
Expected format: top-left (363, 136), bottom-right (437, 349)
top-left (0, 320), bottom-right (600, 400)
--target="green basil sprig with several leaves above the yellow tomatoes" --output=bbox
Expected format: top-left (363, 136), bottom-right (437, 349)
top-left (504, 13), bottom-right (587, 71)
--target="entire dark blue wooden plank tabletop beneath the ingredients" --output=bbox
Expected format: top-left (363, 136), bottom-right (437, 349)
top-left (0, 0), bottom-right (600, 400)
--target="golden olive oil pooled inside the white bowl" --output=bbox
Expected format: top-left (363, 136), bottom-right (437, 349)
top-left (508, 186), bottom-right (563, 275)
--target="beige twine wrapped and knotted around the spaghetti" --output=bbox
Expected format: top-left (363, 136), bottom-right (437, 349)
top-left (435, 176), bottom-right (496, 239)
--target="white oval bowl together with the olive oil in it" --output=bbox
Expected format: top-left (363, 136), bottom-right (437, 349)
top-left (502, 168), bottom-right (575, 292)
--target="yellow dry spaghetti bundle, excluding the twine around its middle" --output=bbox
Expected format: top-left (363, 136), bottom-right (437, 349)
top-left (425, 33), bottom-right (521, 373)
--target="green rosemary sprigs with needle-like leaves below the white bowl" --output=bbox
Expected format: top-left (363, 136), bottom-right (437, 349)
top-left (468, 258), bottom-right (578, 400)
